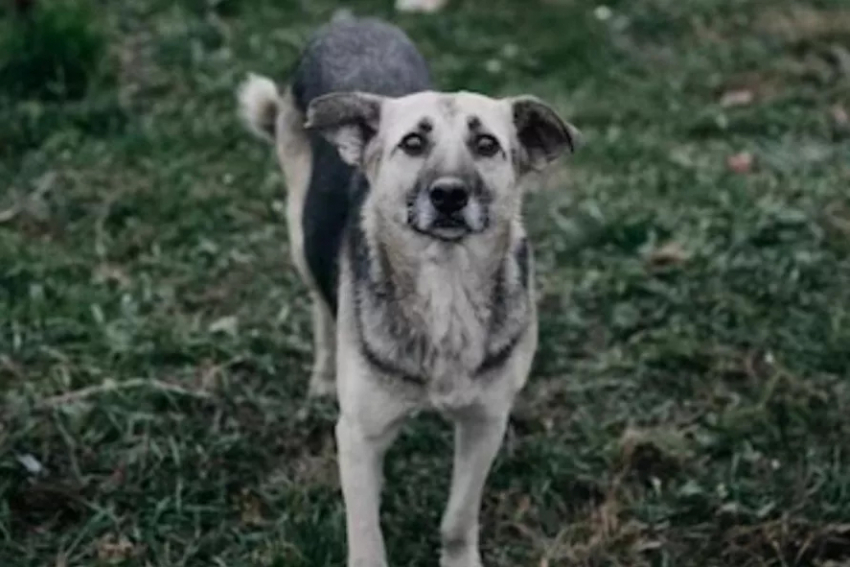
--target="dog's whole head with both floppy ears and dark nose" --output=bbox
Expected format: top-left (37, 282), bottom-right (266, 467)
top-left (306, 92), bottom-right (578, 242)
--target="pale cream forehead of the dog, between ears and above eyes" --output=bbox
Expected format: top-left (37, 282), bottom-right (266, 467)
top-left (383, 92), bottom-right (510, 136)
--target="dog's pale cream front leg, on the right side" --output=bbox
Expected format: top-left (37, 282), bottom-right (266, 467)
top-left (440, 404), bottom-right (510, 567)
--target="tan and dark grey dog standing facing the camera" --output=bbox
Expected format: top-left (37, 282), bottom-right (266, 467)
top-left (239, 17), bottom-right (578, 567)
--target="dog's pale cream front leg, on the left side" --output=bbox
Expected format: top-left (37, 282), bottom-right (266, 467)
top-left (336, 374), bottom-right (408, 567)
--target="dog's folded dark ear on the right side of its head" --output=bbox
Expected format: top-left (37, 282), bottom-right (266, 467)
top-left (509, 96), bottom-right (581, 171)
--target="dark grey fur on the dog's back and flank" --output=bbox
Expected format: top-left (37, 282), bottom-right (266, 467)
top-left (292, 18), bottom-right (432, 312)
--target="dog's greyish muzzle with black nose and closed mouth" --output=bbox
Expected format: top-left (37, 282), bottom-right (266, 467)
top-left (408, 176), bottom-right (487, 241)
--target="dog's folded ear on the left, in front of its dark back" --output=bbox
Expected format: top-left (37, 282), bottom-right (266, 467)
top-left (304, 92), bottom-right (383, 167)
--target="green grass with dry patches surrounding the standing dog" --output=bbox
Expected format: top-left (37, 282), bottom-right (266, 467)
top-left (0, 0), bottom-right (850, 567)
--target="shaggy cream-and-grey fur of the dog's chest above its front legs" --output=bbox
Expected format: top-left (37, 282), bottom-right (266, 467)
top-left (350, 224), bottom-right (529, 408)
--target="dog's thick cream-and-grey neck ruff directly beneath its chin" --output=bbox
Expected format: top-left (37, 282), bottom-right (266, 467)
top-left (352, 210), bottom-right (528, 391)
